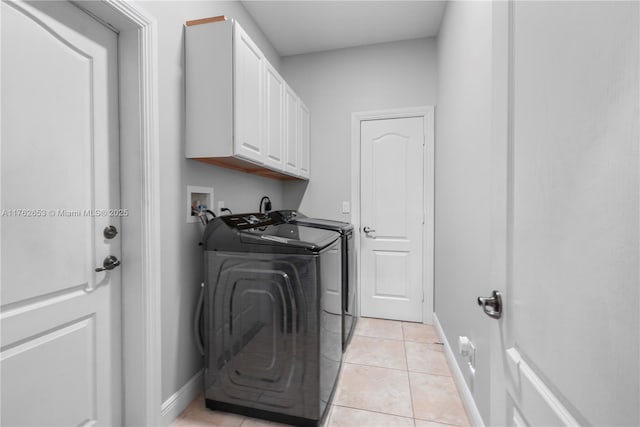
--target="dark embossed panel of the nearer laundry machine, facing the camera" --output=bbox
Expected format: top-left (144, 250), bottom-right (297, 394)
top-left (207, 253), bottom-right (317, 417)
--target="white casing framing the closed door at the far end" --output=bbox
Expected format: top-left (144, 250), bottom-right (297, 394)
top-left (351, 106), bottom-right (435, 324)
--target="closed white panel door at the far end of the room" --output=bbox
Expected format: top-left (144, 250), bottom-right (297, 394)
top-left (360, 117), bottom-right (425, 322)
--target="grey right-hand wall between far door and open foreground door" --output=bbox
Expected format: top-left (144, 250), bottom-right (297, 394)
top-left (435, 2), bottom-right (492, 422)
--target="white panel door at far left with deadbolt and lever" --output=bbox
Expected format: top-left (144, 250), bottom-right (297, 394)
top-left (0, 2), bottom-right (126, 426)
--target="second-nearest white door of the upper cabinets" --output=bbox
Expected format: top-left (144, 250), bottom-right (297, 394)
top-left (264, 60), bottom-right (285, 170)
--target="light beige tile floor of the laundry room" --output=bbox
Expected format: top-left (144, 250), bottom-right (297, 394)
top-left (171, 318), bottom-right (469, 427)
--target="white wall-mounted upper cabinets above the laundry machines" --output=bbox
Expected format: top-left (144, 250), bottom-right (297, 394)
top-left (185, 17), bottom-right (309, 179)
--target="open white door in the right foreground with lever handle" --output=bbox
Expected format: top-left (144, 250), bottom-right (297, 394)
top-left (486, 2), bottom-right (640, 426)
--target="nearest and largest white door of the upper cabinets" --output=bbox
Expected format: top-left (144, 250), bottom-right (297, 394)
top-left (234, 23), bottom-right (264, 163)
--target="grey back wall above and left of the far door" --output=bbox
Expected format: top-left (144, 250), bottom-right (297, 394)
top-left (282, 38), bottom-right (437, 221)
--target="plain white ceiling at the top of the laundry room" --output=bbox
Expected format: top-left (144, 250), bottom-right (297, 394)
top-left (242, 0), bottom-right (446, 56)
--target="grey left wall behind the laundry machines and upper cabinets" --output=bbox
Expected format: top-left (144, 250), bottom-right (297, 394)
top-left (142, 1), bottom-right (282, 401)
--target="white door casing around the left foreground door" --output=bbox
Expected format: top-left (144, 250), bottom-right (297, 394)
top-left (0, 0), bottom-right (161, 425)
